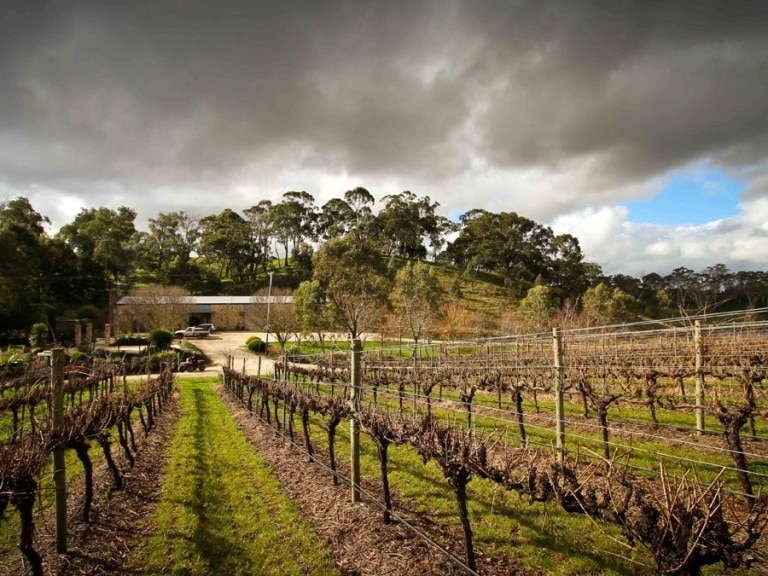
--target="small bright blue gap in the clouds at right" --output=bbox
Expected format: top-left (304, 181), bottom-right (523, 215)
top-left (621, 170), bottom-right (746, 226)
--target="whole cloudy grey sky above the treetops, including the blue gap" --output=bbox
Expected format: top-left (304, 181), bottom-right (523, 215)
top-left (0, 0), bottom-right (768, 276)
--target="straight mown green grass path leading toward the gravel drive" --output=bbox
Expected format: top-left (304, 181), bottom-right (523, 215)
top-left (136, 379), bottom-right (338, 575)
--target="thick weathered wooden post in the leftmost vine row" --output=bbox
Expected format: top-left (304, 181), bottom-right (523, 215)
top-left (51, 348), bottom-right (67, 554)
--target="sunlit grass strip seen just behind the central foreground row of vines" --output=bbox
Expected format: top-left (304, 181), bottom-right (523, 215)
top-left (297, 410), bottom-right (652, 576)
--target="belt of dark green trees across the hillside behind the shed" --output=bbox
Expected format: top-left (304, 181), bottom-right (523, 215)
top-left (0, 191), bottom-right (768, 340)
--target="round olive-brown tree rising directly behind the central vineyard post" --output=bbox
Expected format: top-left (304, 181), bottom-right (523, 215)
top-left (312, 236), bottom-right (391, 339)
